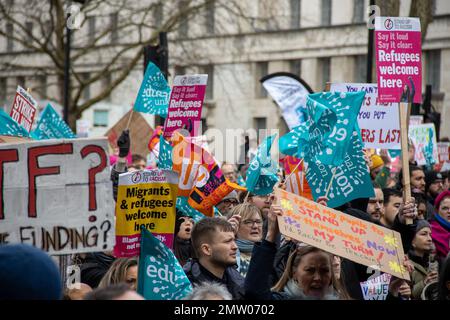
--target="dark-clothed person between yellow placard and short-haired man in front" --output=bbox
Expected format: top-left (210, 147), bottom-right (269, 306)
top-left (173, 210), bottom-right (194, 266)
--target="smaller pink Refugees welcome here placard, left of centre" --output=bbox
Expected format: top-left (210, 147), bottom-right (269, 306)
top-left (164, 74), bottom-right (208, 138)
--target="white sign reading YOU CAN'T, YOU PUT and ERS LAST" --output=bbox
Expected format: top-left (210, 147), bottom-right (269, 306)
top-left (330, 83), bottom-right (401, 150)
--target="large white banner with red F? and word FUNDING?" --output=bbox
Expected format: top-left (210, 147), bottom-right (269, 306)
top-left (0, 139), bottom-right (114, 254)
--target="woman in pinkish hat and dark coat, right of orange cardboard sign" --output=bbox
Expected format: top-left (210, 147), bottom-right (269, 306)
top-left (408, 220), bottom-right (438, 299)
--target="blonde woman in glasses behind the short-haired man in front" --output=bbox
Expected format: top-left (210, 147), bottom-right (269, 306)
top-left (228, 203), bottom-right (263, 277)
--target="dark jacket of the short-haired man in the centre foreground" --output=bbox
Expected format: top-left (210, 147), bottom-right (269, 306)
top-left (183, 259), bottom-right (244, 300)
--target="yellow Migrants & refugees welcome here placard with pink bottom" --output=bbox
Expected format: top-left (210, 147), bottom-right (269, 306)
top-left (114, 169), bottom-right (178, 257)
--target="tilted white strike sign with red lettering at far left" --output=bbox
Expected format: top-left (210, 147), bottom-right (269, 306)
top-left (10, 86), bottom-right (37, 132)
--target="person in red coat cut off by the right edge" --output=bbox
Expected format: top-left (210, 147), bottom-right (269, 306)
top-left (431, 190), bottom-right (450, 260)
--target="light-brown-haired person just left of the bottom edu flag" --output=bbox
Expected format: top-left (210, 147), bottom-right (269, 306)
top-left (98, 258), bottom-right (138, 290)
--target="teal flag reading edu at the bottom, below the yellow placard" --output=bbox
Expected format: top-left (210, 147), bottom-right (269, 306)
top-left (136, 228), bottom-right (192, 300)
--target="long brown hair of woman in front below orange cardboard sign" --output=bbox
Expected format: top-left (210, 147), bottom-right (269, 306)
top-left (272, 245), bottom-right (350, 300)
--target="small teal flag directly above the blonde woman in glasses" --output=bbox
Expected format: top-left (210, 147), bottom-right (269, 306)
top-left (245, 134), bottom-right (278, 195)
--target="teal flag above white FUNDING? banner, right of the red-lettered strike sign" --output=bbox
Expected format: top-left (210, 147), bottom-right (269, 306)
top-left (31, 104), bottom-right (77, 140)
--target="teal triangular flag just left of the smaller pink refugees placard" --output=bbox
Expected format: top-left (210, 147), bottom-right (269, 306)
top-left (133, 62), bottom-right (170, 117)
